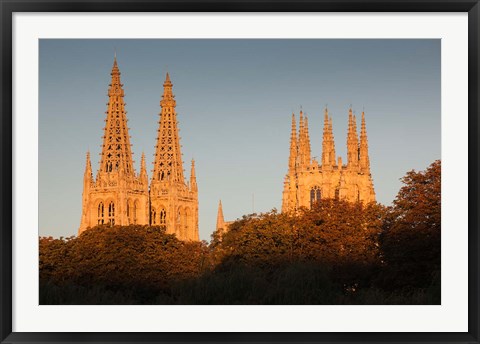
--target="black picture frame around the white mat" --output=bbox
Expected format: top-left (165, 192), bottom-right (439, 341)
top-left (0, 0), bottom-right (480, 343)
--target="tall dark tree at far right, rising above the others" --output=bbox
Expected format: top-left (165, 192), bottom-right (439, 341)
top-left (382, 160), bottom-right (441, 288)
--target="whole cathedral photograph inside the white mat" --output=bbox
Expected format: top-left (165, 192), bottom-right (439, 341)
top-left (38, 38), bottom-right (442, 305)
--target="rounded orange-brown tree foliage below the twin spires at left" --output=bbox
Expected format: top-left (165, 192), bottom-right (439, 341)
top-left (40, 225), bottom-right (207, 298)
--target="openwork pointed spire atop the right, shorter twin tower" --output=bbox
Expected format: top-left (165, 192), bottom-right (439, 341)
top-left (152, 73), bottom-right (185, 183)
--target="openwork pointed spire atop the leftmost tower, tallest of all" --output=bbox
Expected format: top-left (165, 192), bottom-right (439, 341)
top-left (99, 58), bottom-right (135, 178)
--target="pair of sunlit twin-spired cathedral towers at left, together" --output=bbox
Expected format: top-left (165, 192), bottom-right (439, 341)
top-left (78, 58), bottom-right (198, 240)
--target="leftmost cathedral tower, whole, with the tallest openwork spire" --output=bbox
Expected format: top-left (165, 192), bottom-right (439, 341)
top-left (78, 58), bottom-right (149, 234)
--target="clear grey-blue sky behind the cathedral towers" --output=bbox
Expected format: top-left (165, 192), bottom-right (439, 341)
top-left (39, 39), bottom-right (441, 240)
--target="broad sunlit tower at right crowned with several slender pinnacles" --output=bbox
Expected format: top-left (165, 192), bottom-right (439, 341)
top-left (282, 109), bottom-right (375, 212)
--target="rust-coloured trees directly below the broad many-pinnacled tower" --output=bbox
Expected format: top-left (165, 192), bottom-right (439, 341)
top-left (215, 199), bottom-right (385, 291)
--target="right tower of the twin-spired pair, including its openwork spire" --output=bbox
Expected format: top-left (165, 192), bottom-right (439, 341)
top-left (150, 73), bottom-right (198, 240)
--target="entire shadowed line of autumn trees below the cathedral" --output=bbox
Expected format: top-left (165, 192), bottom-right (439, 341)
top-left (39, 161), bottom-right (441, 304)
